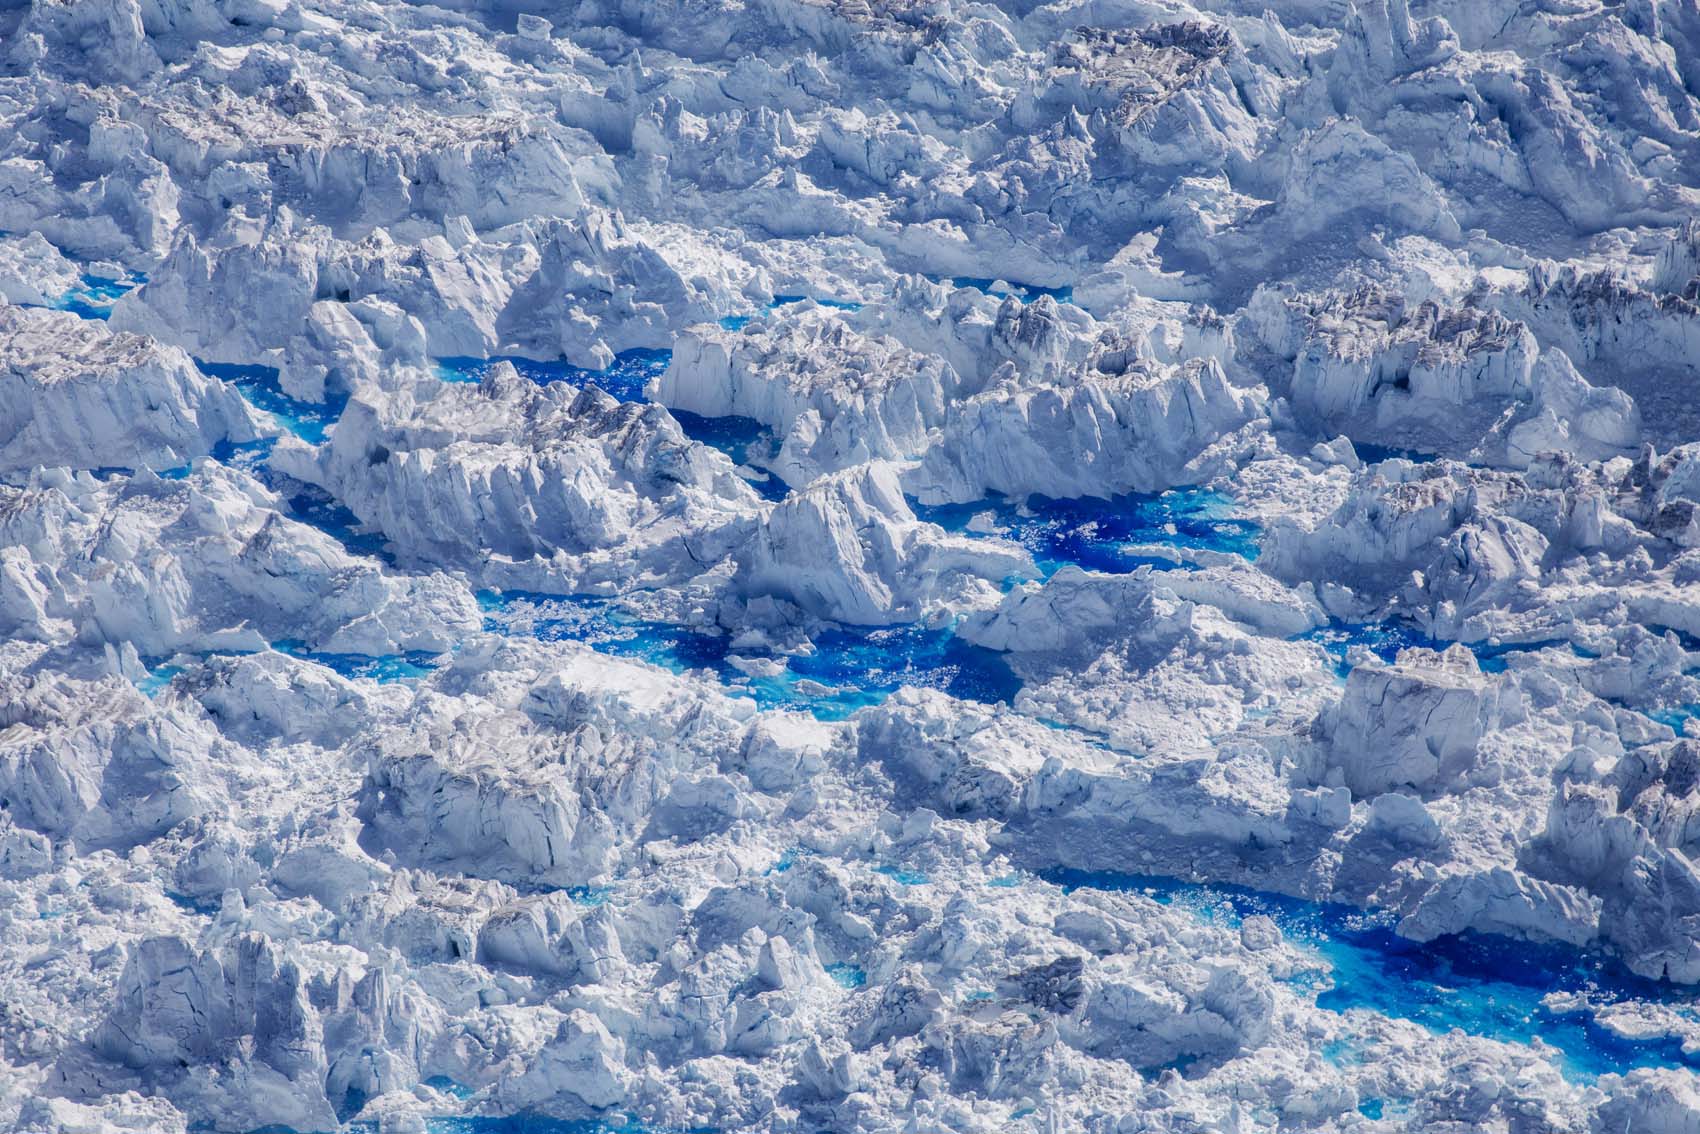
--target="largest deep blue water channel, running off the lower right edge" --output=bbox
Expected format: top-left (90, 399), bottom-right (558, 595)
top-left (1042, 870), bottom-right (1700, 1080)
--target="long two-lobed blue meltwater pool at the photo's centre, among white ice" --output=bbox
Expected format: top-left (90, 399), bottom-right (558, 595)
top-left (478, 592), bottom-right (1020, 721)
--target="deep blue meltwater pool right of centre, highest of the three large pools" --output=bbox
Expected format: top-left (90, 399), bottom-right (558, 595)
top-left (910, 488), bottom-right (1260, 578)
